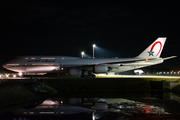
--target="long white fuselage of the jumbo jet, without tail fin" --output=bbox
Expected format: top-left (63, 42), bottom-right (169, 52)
top-left (3, 56), bottom-right (163, 73)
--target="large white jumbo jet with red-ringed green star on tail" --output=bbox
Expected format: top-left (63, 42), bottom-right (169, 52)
top-left (3, 37), bottom-right (176, 77)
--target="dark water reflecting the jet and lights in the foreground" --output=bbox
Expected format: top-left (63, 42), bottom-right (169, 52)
top-left (0, 91), bottom-right (180, 120)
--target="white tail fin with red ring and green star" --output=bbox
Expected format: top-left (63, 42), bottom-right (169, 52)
top-left (137, 37), bottom-right (166, 58)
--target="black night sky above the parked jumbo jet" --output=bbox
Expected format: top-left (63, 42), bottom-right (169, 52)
top-left (0, 0), bottom-right (180, 68)
